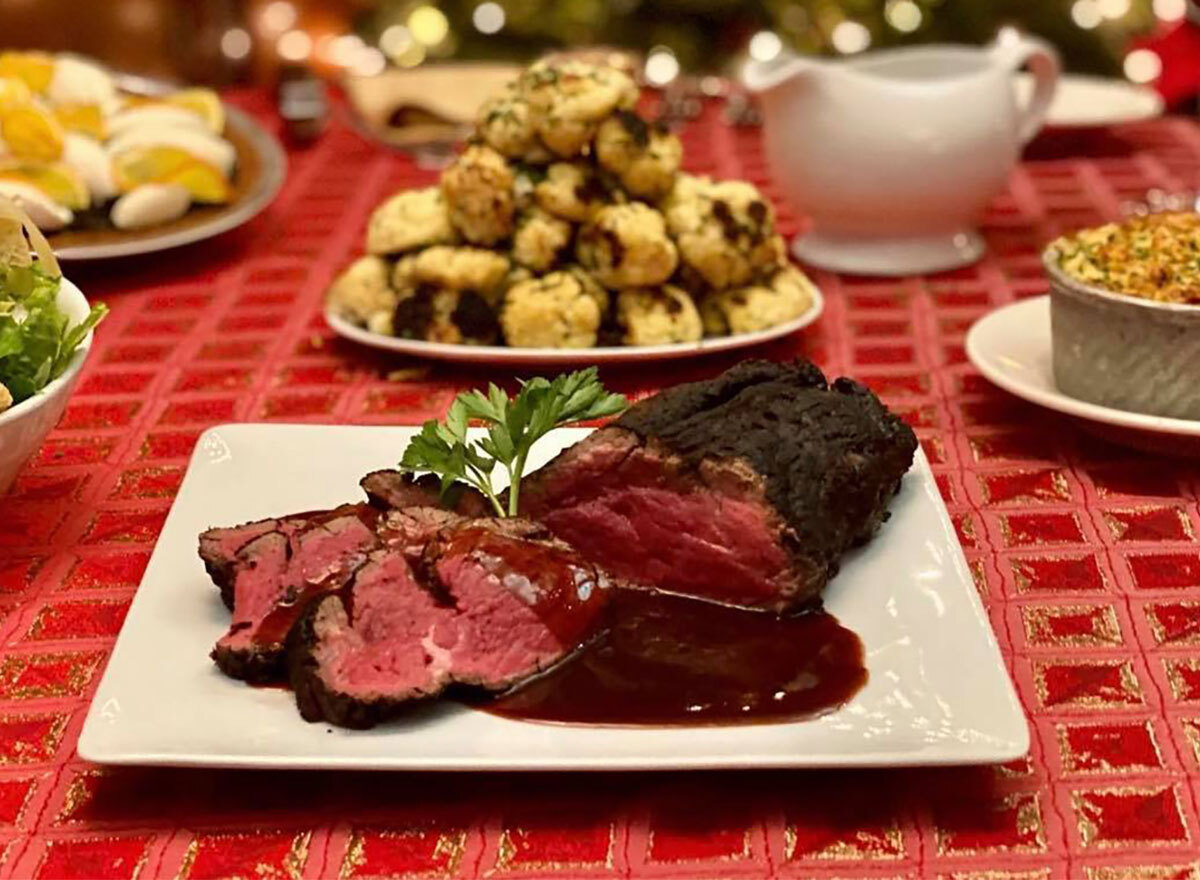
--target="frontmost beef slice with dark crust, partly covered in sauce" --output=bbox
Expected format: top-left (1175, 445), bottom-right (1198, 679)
top-left (288, 519), bottom-right (607, 728)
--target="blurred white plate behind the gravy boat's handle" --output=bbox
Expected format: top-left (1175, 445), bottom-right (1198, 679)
top-left (1016, 73), bottom-right (1163, 128)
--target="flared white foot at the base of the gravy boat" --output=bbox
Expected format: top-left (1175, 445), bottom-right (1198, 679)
top-left (792, 229), bottom-right (986, 277)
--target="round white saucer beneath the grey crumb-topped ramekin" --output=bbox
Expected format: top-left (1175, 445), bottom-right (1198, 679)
top-left (966, 297), bottom-right (1200, 451)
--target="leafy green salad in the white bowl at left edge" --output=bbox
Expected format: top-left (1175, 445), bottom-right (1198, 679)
top-left (0, 198), bottom-right (108, 411)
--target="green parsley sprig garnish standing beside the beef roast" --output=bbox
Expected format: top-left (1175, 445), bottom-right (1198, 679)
top-left (400, 366), bottom-right (629, 516)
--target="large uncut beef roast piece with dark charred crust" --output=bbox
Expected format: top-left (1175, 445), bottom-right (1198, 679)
top-left (521, 360), bottom-right (917, 611)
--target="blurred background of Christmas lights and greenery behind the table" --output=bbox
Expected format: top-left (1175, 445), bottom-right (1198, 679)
top-left (0, 0), bottom-right (1200, 106)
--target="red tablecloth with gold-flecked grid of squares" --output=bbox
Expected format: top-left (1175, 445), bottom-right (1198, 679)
top-left (0, 94), bottom-right (1200, 880)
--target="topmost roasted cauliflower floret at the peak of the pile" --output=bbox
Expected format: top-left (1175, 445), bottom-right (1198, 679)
top-left (521, 61), bottom-right (637, 158)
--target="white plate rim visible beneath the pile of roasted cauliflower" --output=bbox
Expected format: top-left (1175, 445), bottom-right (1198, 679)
top-left (325, 287), bottom-right (824, 366)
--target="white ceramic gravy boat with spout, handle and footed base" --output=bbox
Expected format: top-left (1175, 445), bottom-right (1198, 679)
top-left (743, 30), bottom-right (1060, 275)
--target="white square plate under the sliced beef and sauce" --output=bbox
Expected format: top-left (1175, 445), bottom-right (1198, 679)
top-left (79, 425), bottom-right (1030, 770)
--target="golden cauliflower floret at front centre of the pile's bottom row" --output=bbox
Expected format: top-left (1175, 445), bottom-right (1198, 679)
top-left (500, 271), bottom-right (604, 348)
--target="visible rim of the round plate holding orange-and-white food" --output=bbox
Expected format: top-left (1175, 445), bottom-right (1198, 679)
top-left (52, 104), bottom-right (288, 261)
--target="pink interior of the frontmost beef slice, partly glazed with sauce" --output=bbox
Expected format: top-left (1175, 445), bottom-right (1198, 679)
top-left (300, 527), bottom-right (607, 700)
